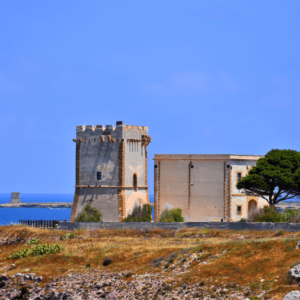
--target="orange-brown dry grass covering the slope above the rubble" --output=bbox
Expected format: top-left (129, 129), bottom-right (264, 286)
top-left (0, 226), bottom-right (300, 299)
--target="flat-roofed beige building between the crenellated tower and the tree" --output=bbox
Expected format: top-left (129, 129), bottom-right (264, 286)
top-left (154, 154), bottom-right (268, 222)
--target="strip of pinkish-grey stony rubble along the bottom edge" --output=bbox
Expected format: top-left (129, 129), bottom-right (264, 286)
top-left (0, 271), bottom-right (253, 300)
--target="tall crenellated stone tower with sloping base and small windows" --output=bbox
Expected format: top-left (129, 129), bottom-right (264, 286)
top-left (71, 122), bottom-right (151, 222)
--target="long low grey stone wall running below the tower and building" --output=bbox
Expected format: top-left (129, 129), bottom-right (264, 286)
top-left (58, 222), bottom-right (300, 231)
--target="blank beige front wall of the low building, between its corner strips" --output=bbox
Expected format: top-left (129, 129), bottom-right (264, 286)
top-left (159, 159), bottom-right (224, 222)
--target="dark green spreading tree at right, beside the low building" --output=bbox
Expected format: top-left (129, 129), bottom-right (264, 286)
top-left (236, 149), bottom-right (300, 206)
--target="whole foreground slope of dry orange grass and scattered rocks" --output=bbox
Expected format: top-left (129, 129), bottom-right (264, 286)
top-left (0, 226), bottom-right (300, 300)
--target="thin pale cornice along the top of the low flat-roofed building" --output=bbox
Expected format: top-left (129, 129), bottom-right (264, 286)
top-left (153, 154), bottom-right (264, 160)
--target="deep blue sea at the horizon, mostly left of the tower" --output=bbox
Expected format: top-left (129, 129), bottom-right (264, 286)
top-left (0, 193), bottom-right (154, 225)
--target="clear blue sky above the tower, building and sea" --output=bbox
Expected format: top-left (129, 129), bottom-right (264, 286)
top-left (0, 0), bottom-right (300, 194)
